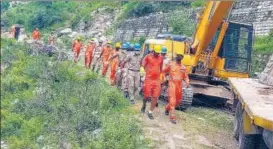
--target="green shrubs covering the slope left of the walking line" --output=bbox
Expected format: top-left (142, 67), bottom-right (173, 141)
top-left (1, 39), bottom-right (146, 149)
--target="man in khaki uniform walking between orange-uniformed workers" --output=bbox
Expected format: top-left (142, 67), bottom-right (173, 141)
top-left (92, 40), bottom-right (103, 73)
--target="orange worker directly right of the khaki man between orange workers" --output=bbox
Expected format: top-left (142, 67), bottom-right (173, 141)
top-left (100, 41), bottom-right (112, 76)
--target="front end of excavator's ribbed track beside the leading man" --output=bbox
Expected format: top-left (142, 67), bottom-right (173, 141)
top-left (177, 87), bottom-right (193, 111)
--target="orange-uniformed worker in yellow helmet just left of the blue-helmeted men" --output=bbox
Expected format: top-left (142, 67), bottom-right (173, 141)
top-left (109, 42), bottom-right (121, 85)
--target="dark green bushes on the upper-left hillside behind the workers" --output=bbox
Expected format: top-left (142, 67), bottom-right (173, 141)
top-left (1, 1), bottom-right (119, 31)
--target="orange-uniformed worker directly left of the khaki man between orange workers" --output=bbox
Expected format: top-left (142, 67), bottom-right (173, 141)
top-left (84, 38), bottom-right (96, 69)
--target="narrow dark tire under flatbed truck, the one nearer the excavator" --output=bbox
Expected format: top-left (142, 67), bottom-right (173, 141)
top-left (233, 101), bottom-right (243, 141)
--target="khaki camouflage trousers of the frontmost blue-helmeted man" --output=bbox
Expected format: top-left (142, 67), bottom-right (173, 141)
top-left (128, 70), bottom-right (140, 100)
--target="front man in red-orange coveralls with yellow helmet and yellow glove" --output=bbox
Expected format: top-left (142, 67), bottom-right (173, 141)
top-left (141, 45), bottom-right (163, 119)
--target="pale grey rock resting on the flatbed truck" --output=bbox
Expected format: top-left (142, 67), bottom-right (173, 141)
top-left (259, 54), bottom-right (273, 86)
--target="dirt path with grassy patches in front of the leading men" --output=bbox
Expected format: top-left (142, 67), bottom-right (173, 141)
top-left (133, 104), bottom-right (238, 149)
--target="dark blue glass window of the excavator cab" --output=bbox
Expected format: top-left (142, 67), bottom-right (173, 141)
top-left (219, 22), bottom-right (253, 73)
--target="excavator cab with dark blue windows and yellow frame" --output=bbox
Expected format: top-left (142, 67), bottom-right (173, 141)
top-left (204, 22), bottom-right (254, 79)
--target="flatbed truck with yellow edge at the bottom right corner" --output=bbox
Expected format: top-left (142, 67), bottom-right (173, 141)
top-left (228, 55), bottom-right (273, 149)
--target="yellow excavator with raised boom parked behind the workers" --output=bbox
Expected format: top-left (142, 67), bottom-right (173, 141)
top-left (142, 0), bottom-right (254, 109)
